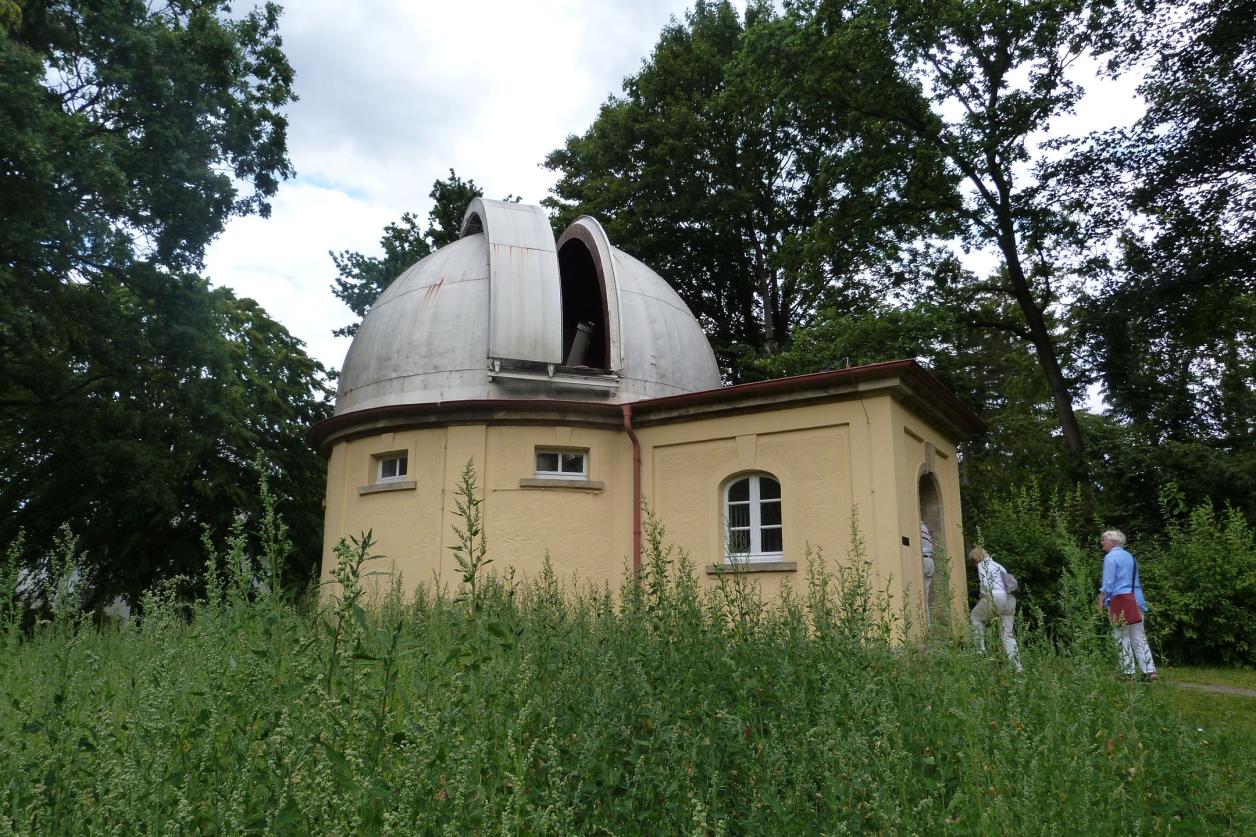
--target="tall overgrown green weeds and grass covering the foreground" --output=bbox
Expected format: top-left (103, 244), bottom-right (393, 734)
top-left (0, 471), bottom-right (1256, 834)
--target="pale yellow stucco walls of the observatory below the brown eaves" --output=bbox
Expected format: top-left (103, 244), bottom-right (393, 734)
top-left (323, 395), bottom-right (963, 633)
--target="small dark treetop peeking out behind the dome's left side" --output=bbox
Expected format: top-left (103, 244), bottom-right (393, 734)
top-left (330, 168), bottom-right (487, 337)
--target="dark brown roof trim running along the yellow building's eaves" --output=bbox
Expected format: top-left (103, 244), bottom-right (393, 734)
top-left (308, 359), bottom-right (986, 452)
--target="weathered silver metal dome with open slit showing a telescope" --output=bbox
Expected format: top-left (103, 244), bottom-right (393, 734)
top-left (335, 199), bottom-right (720, 415)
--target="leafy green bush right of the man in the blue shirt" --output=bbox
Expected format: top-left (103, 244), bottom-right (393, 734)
top-left (1139, 485), bottom-right (1256, 666)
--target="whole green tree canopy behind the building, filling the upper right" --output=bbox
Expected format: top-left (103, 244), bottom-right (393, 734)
top-left (546, 0), bottom-right (1256, 520)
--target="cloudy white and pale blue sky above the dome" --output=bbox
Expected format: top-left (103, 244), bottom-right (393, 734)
top-left (206, 0), bottom-right (1137, 368)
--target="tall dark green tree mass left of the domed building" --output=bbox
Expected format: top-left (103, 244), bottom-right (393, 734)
top-left (0, 0), bottom-right (325, 601)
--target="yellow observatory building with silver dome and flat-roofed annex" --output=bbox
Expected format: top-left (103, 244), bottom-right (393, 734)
top-left (310, 199), bottom-right (981, 625)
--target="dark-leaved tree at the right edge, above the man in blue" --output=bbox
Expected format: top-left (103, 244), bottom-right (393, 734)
top-left (1058, 0), bottom-right (1256, 522)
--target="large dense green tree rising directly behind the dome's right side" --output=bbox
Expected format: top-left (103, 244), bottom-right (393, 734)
top-left (545, 3), bottom-right (951, 380)
